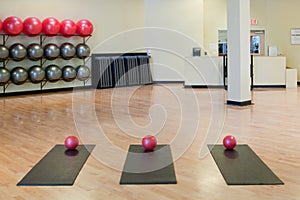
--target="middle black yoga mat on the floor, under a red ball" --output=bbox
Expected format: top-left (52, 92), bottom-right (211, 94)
top-left (120, 145), bottom-right (177, 184)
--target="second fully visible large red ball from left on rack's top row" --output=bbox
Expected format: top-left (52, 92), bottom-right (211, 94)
top-left (23, 17), bottom-right (43, 36)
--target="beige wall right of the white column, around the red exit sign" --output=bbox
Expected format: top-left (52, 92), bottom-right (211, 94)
top-left (251, 0), bottom-right (300, 81)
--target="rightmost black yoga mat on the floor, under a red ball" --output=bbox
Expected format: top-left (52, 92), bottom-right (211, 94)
top-left (208, 145), bottom-right (284, 185)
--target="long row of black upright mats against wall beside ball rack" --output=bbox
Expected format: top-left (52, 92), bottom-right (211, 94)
top-left (92, 53), bottom-right (152, 89)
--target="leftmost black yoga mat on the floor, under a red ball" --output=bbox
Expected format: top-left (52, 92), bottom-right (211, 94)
top-left (17, 145), bottom-right (95, 186)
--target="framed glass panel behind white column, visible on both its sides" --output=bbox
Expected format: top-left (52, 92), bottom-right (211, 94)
top-left (218, 30), bottom-right (265, 56)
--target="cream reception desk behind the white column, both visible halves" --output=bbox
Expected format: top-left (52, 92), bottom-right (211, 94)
top-left (184, 56), bottom-right (286, 86)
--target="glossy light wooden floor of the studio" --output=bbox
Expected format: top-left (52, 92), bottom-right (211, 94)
top-left (0, 84), bottom-right (300, 200)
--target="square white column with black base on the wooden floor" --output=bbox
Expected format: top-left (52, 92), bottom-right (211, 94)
top-left (227, 0), bottom-right (251, 106)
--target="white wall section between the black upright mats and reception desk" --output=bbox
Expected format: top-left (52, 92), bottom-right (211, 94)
top-left (144, 0), bottom-right (203, 81)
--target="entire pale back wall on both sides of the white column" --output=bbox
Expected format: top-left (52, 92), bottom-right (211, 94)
top-left (0, 0), bottom-right (300, 81)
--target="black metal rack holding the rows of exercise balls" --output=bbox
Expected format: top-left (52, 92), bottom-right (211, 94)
top-left (0, 33), bottom-right (92, 96)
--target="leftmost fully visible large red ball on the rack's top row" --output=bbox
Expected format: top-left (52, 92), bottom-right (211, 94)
top-left (3, 16), bottom-right (23, 36)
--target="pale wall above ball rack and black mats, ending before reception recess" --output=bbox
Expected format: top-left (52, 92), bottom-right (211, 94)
top-left (0, 0), bottom-right (203, 81)
